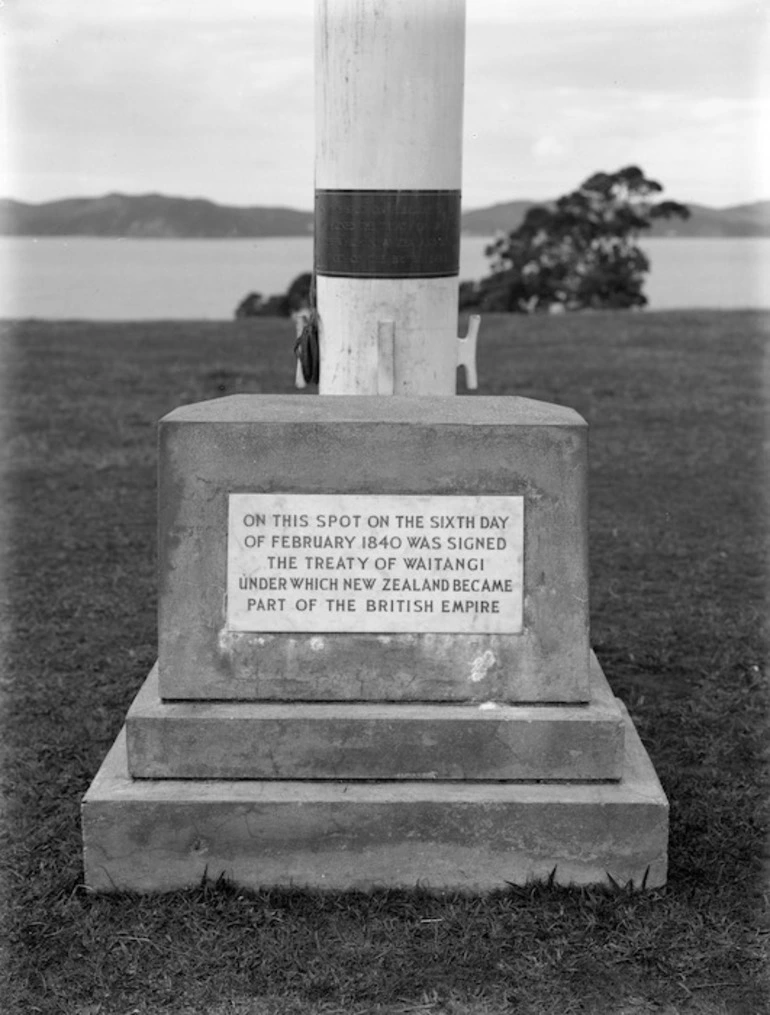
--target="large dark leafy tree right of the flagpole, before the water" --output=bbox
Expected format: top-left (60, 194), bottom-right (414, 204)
top-left (478, 165), bottom-right (690, 313)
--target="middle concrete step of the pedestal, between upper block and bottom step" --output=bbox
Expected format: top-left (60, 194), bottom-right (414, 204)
top-left (126, 657), bottom-right (624, 781)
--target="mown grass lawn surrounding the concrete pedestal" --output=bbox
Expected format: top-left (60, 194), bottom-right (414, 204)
top-left (0, 312), bottom-right (770, 1015)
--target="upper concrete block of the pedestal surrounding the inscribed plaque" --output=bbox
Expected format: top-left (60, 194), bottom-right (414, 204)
top-left (158, 395), bottom-right (589, 702)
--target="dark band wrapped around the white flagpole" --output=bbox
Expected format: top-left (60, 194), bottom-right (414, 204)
top-left (314, 190), bottom-right (461, 278)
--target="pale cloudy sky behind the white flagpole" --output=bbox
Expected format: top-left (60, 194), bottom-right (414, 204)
top-left (0, 0), bottom-right (770, 209)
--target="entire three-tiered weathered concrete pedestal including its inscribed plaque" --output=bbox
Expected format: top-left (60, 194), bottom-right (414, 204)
top-left (82, 396), bottom-right (668, 891)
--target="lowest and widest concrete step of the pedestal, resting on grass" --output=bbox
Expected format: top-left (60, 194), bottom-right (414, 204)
top-left (82, 702), bottom-right (668, 891)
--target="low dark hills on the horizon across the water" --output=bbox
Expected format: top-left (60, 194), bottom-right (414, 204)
top-left (0, 194), bottom-right (770, 240)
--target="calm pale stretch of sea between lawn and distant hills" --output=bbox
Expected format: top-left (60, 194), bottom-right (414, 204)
top-left (0, 236), bottom-right (770, 321)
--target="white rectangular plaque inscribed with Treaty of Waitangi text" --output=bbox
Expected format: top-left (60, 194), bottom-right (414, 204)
top-left (227, 493), bottom-right (523, 634)
